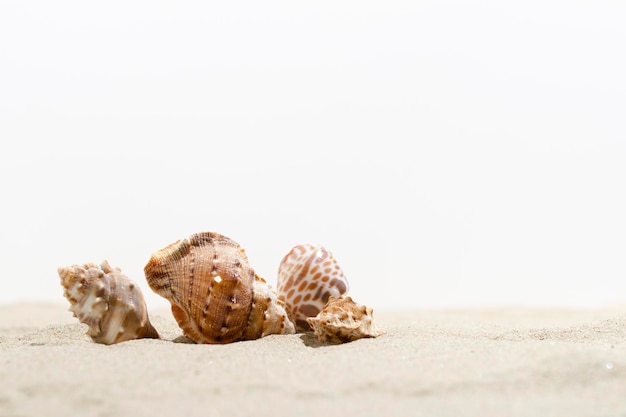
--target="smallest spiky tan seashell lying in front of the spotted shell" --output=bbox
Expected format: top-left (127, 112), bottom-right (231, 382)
top-left (307, 297), bottom-right (383, 343)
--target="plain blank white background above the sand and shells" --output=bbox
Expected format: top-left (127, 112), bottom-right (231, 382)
top-left (0, 0), bottom-right (626, 309)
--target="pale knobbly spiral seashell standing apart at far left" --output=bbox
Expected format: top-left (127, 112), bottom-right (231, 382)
top-left (58, 260), bottom-right (159, 345)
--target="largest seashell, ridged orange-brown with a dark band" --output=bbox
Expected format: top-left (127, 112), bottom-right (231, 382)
top-left (144, 232), bottom-right (295, 343)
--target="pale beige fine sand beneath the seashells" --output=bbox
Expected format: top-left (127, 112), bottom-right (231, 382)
top-left (0, 304), bottom-right (626, 417)
